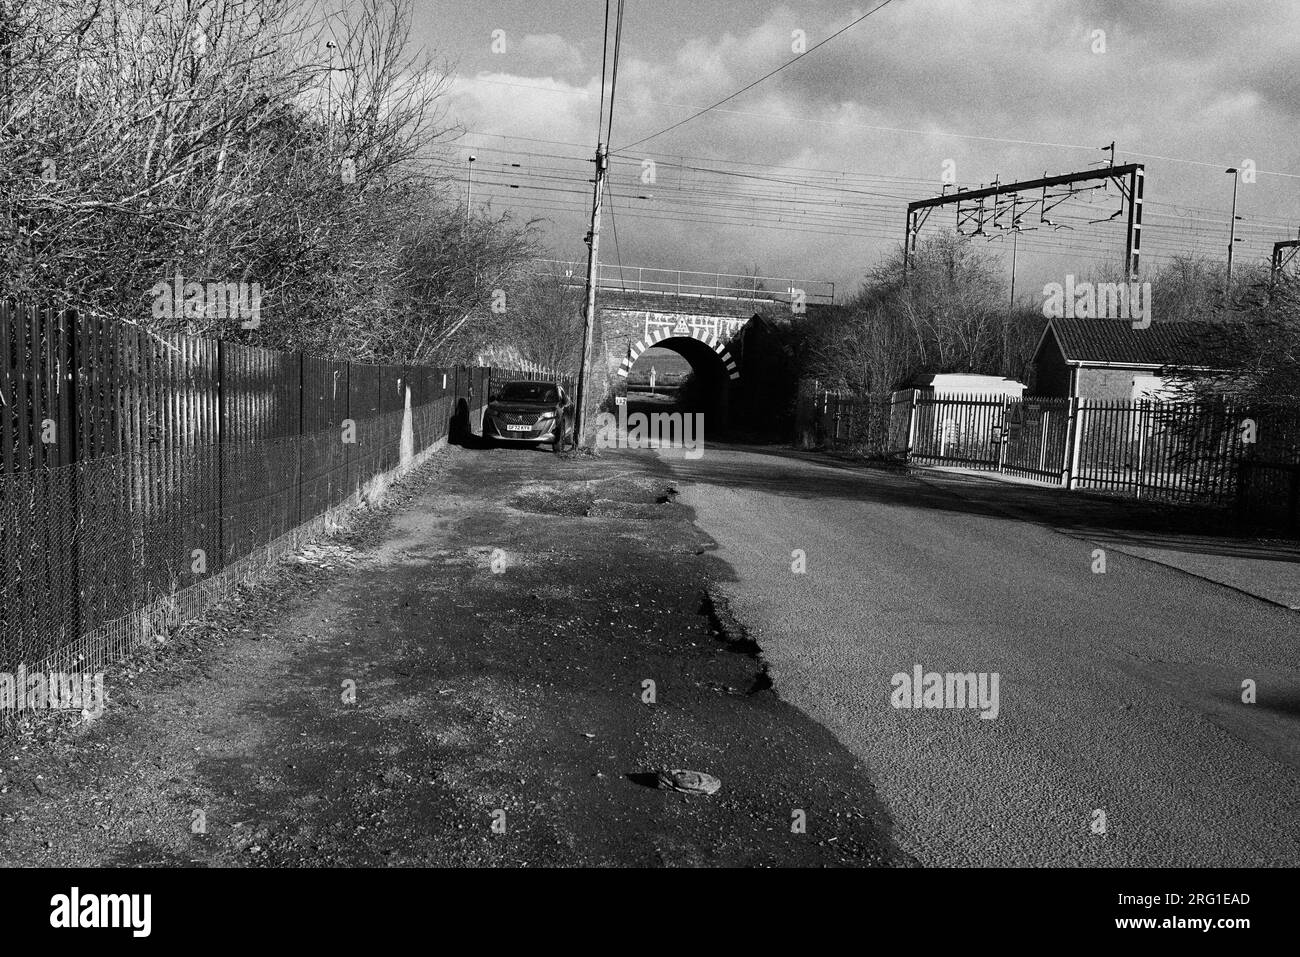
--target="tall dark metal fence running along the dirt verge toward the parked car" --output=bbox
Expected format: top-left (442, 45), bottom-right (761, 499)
top-left (0, 303), bottom-right (569, 672)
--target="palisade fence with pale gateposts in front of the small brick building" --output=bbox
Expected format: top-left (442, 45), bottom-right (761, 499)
top-left (801, 389), bottom-right (1300, 527)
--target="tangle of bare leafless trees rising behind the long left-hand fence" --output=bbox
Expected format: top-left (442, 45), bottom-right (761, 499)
top-left (0, 0), bottom-right (533, 360)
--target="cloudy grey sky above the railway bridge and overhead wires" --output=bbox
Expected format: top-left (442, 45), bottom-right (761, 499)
top-left (412, 0), bottom-right (1300, 299)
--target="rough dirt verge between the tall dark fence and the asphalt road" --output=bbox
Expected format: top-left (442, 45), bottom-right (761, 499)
top-left (0, 449), bottom-right (911, 867)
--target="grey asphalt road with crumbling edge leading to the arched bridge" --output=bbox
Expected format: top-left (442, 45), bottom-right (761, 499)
top-left (660, 445), bottom-right (1300, 866)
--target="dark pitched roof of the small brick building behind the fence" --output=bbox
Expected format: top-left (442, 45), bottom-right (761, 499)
top-left (1039, 319), bottom-right (1212, 367)
